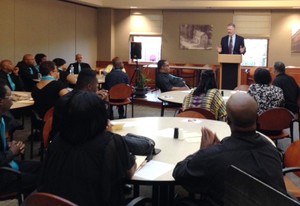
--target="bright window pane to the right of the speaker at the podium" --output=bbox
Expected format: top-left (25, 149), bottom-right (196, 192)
top-left (242, 39), bottom-right (269, 67)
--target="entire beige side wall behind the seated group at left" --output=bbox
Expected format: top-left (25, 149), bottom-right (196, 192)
top-left (0, 0), bottom-right (98, 66)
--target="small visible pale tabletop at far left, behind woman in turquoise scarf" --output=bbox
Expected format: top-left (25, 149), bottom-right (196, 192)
top-left (10, 91), bottom-right (34, 109)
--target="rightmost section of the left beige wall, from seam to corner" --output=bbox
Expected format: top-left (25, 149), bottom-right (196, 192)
top-left (74, 6), bottom-right (98, 67)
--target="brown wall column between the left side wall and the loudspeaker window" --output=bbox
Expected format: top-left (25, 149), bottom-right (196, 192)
top-left (97, 9), bottom-right (114, 61)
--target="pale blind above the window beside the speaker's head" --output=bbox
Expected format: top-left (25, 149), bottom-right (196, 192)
top-left (233, 11), bottom-right (271, 38)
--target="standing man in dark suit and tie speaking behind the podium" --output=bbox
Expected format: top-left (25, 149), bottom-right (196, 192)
top-left (217, 23), bottom-right (246, 54)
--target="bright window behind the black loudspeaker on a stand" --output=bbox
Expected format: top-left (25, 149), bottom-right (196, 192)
top-left (129, 35), bottom-right (161, 62)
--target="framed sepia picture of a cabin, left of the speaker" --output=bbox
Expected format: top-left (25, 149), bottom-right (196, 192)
top-left (179, 24), bottom-right (212, 50)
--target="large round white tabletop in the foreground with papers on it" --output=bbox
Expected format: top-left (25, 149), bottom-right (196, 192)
top-left (112, 117), bottom-right (231, 181)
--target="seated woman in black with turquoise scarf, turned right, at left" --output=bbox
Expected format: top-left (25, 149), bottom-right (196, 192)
top-left (31, 61), bottom-right (68, 118)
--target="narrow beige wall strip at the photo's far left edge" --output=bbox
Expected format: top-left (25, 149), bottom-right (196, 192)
top-left (0, 0), bottom-right (15, 61)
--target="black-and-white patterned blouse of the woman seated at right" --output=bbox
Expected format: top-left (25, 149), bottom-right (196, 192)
top-left (248, 84), bottom-right (284, 115)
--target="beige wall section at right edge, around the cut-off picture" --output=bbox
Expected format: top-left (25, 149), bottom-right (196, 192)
top-left (268, 11), bottom-right (300, 66)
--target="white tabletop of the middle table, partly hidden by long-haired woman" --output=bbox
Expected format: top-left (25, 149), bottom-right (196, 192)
top-left (158, 89), bottom-right (244, 104)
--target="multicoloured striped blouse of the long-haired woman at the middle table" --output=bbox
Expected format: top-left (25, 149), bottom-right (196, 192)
top-left (182, 89), bottom-right (227, 120)
